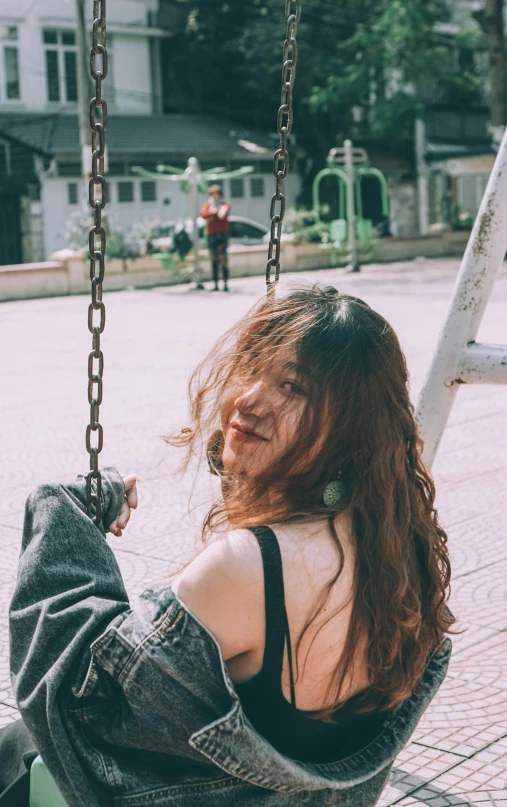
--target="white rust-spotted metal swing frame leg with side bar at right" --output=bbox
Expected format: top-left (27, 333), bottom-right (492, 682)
top-left (417, 126), bottom-right (507, 465)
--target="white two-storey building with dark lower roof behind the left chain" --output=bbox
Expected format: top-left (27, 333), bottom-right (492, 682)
top-left (0, 0), bottom-right (299, 264)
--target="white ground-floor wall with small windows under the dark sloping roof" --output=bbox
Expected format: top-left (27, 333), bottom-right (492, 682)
top-left (42, 174), bottom-right (300, 259)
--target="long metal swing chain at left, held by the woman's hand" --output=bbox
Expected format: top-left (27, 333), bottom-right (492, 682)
top-left (86, 0), bottom-right (107, 525)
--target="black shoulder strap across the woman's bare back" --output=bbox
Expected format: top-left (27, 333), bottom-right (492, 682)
top-left (251, 527), bottom-right (296, 706)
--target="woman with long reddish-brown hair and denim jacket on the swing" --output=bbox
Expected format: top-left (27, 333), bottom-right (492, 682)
top-left (3, 286), bottom-right (454, 807)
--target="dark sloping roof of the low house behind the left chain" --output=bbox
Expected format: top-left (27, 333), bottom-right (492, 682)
top-left (0, 113), bottom-right (284, 160)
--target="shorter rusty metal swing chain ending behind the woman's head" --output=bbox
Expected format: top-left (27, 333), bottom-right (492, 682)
top-left (266, 0), bottom-right (302, 298)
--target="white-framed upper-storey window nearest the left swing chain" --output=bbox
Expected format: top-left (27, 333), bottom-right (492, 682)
top-left (42, 29), bottom-right (77, 104)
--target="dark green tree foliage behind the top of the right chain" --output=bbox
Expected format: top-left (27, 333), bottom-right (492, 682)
top-left (163, 0), bottom-right (464, 167)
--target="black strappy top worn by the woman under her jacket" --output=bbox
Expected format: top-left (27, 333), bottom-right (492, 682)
top-left (235, 527), bottom-right (382, 763)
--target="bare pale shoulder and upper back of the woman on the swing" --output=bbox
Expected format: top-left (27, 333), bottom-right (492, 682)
top-left (173, 514), bottom-right (369, 732)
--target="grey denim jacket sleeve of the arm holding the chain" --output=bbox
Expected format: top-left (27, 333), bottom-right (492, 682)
top-left (10, 468), bottom-right (236, 807)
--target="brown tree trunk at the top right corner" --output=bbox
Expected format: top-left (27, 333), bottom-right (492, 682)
top-left (474, 0), bottom-right (507, 143)
